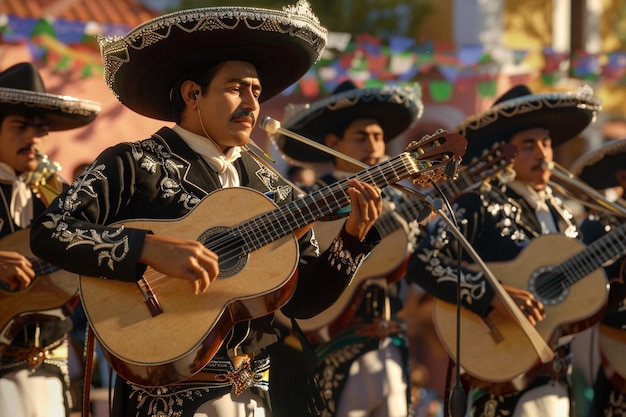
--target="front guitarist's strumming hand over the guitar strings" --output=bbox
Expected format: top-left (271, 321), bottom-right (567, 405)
top-left (139, 235), bottom-right (220, 294)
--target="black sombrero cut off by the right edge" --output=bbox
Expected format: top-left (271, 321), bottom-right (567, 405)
top-left (570, 138), bottom-right (626, 190)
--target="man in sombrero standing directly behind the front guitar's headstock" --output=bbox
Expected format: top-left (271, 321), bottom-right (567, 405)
top-left (271, 80), bottom-right (423, 417)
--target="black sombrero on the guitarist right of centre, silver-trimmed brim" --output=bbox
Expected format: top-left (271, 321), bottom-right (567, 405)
top-left (455, 85), bottom-right (602, 161)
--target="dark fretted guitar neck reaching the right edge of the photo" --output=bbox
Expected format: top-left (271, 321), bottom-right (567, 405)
top-left (558, 224), bottom-right (626, 287)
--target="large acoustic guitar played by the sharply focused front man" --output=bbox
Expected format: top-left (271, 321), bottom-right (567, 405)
top-left (79, 132), bottom-right (467, 386)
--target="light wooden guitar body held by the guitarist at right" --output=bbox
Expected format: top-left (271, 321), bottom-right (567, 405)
top-left (433, 234), bottom-right (608, 383)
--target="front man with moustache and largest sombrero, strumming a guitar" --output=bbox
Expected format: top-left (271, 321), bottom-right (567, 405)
top-left (32, 0), bottom-right (381, 417)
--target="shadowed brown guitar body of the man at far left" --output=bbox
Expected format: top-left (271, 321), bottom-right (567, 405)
top-left (0, 229), bottom-right (79, 351)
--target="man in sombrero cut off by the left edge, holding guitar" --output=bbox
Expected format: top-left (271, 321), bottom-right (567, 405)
top-left (0, 62), bottom-right (100, 417)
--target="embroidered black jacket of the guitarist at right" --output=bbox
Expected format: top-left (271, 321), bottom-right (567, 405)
top-left (407, 180), bottom-right (579, 315)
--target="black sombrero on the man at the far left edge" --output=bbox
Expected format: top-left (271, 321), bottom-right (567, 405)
top-left (0, 62), bottom-right (101, 131)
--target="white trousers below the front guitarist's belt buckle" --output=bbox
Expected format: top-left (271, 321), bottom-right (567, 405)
top-left (194, 389), bottom-right (266, 417)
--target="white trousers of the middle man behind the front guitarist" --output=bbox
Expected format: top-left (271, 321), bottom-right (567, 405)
top-left (336, 339), bottom-right (408, 417)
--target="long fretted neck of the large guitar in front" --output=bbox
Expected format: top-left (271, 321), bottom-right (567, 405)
top-left (236, 152), bottom-right (420, 252)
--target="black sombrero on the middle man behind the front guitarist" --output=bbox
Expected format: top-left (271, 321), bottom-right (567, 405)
top-left (270, 81), bottom-right (424, 164)
